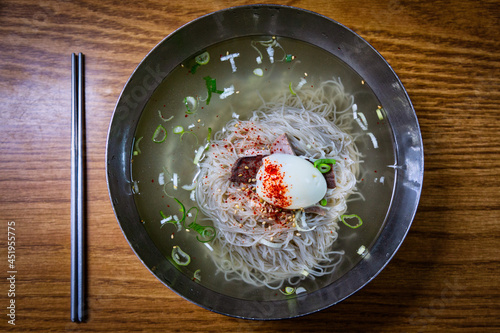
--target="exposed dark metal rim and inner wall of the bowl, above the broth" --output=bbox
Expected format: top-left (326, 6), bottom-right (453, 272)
top-left (106, 5), bottom-right (424, 319)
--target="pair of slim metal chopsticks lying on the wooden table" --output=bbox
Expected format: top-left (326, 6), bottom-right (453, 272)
top-left (71, 53), bottom-right (85, 322)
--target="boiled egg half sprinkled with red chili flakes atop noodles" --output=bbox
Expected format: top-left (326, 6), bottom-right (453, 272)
top-left (256, 154), bottom-right (327, 209)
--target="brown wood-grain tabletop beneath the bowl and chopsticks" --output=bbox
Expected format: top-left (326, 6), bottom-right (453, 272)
top-left (0, 0), bottom-right (500, 332)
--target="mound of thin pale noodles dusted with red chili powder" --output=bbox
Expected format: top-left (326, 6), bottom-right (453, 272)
top-left (196, 80), bottom-right (359, 289)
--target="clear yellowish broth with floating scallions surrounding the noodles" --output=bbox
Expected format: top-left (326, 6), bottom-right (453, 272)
top-left (131, 36), bottom-right (396, 300)
